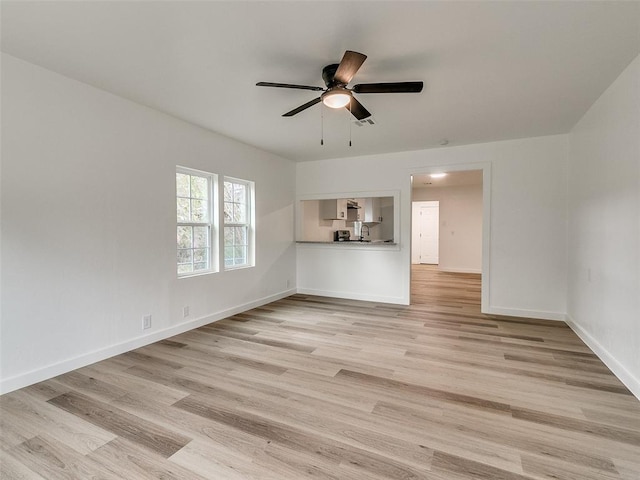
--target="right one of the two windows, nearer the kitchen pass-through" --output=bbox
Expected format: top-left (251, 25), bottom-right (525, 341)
top-left (224, 177), bottom-right (254, 269)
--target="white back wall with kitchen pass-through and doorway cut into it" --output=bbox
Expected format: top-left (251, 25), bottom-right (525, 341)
top-left (296, 135), bottom-right (567, 319)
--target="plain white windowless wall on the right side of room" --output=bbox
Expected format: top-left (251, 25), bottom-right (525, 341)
top-left (568, 53), bottom-right (640, 398)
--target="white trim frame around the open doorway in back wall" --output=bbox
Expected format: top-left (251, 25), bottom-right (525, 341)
top-left (407, 162), bottom-right (491, 313)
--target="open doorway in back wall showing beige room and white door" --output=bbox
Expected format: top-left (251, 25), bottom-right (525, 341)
top-left (410, 167), bottom-right (489, 307)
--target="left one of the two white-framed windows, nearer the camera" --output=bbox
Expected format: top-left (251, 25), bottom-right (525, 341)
top-left (176, 167), bottom-right (215, 276)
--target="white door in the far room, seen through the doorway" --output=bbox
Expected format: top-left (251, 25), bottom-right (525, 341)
top-left (411, 202), bottom-right (440, 265)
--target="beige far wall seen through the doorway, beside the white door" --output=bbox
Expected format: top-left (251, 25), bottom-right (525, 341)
top-left (412, 185), bottom-right (482, 273)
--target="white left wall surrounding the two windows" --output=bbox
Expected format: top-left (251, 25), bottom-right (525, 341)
top-left (0, 54), bottom-right (295, 391)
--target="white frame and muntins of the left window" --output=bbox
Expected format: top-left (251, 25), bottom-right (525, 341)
top-left (175, 166), bottom-right (219, 278)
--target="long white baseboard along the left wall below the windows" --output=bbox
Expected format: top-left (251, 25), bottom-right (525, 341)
top-left (0, 289), bottom-right (296, 395)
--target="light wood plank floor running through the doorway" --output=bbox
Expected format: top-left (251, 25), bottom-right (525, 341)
top-left (0, 266), bottom-right (640, 480)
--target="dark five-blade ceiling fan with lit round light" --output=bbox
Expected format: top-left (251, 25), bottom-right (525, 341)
top-left (256, 50), bottom-right (423, 120)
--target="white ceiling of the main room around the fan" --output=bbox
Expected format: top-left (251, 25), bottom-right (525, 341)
top-left (0, 1), bottom-right (640, 161)
